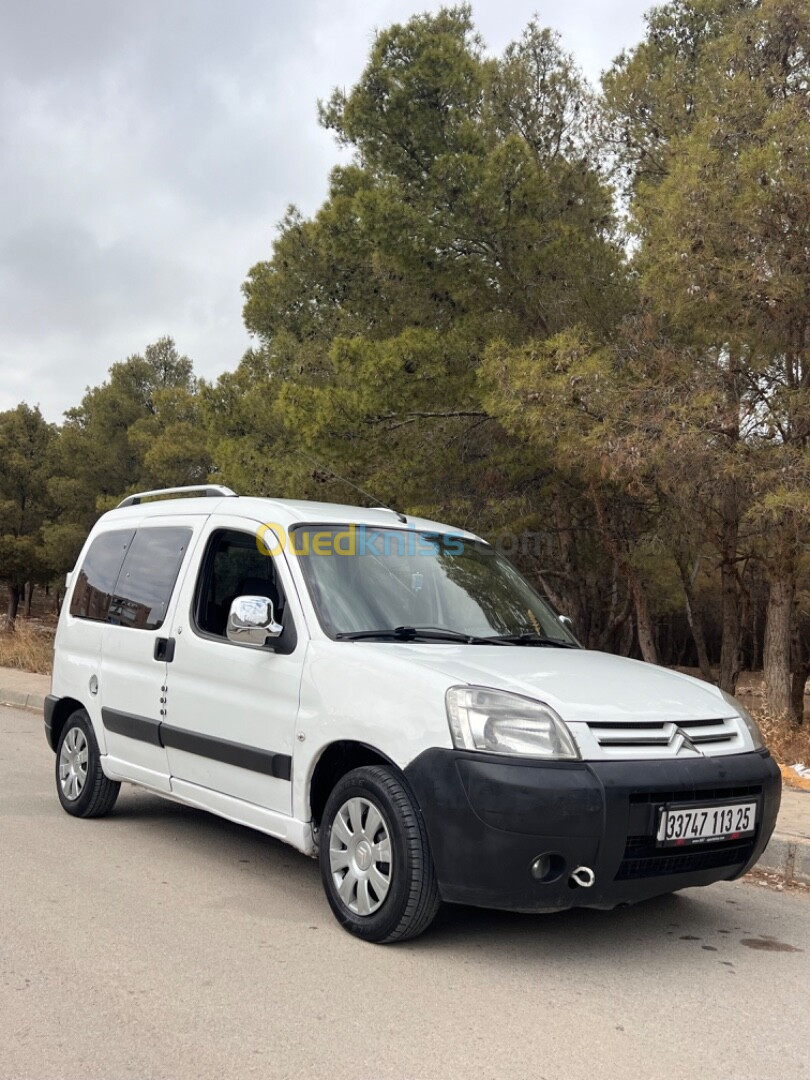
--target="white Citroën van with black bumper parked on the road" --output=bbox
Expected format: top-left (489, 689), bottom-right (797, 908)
top-left (45, 487), bottom-right (781, 942)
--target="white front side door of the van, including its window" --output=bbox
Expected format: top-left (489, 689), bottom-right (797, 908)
top-left (161, 516), bottom-right (307, 814)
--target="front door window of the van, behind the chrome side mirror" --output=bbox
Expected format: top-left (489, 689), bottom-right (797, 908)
top-left (194, 529), bottom-right (284, 638)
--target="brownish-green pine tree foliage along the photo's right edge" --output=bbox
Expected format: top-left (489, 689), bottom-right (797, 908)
top-left (608, 0), bottom-right (810, 558)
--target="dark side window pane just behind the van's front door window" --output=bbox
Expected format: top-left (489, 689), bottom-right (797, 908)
top-left (107, 526), bottom-right (191, 630)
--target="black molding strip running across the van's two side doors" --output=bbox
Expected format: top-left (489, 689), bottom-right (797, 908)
top-left (102, 708), bottom-right (293, 781)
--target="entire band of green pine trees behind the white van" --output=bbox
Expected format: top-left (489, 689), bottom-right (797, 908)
top-left (0, 0), bottom-right (810, 689)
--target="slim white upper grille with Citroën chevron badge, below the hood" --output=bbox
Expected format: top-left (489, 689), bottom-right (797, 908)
top-left (584, 717), bottom-right (745, 758)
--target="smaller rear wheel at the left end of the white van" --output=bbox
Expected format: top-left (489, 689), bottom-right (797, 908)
top-left (56, 708), bottom-right (121, 818)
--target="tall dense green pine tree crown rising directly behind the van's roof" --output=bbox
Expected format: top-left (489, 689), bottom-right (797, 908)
top-left (234, 8), bottom-right (630, 527)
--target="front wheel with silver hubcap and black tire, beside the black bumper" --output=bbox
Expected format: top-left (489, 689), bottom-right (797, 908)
top-left (319, 766), bottom-right (441, 944)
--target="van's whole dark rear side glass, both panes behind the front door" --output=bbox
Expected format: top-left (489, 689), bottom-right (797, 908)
top-left (70, 527), bottom-right (191, 630)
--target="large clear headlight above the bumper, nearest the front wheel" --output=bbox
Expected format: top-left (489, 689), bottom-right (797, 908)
top-left (445, 686), bottom-right (580, 761)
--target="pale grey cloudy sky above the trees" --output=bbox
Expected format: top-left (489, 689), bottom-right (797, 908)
top-left (0, 0), bottom-right (650, 420)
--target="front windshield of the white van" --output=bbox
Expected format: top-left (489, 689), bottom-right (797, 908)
top-left (293, 525), bottom-right (577, 646)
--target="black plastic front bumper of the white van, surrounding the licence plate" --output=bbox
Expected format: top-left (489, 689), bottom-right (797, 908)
top-left (405, 750), bottom-right (782, 912)
